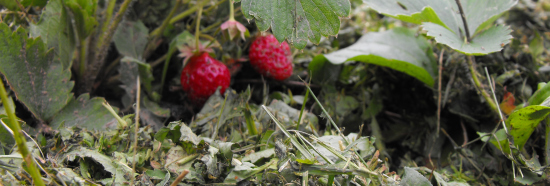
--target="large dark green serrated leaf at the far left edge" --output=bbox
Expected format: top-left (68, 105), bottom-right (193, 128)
top-left (0, 23), bottom-right (74, 122)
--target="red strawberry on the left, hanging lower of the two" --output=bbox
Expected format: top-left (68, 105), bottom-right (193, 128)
top-left (181, 52), bottom-right (231, 104)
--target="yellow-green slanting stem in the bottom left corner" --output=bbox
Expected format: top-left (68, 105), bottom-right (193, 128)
top-left (0, 80), bottom-right (44, 186)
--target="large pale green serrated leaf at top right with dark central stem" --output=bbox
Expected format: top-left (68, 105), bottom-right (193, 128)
top-left (363, 0), bottom-right (517, 55)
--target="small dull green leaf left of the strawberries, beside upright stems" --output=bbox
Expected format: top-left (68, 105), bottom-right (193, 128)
top-left (113, 21), bottom-right (149, 59)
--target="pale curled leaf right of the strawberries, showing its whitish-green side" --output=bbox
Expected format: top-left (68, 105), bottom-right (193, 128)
top-left (312, 28), bottom-right (436, 86)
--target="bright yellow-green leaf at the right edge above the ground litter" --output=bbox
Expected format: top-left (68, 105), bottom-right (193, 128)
top-left (506, 105), bottom-right (550, 149)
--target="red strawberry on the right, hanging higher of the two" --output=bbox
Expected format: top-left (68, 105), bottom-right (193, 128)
top-left (248, 34), bottom-right (292, 81)
